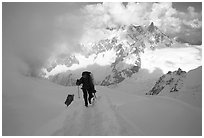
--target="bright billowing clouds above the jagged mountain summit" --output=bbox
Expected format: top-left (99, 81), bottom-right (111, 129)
top-left (82, 2), bottom-right (202, 42)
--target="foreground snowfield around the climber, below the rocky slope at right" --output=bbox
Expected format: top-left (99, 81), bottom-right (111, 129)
top-left (2, 76), bottom-right (202, 136)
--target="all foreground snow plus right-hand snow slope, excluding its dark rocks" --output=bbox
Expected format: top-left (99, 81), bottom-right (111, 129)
top-left (2, 45), bottom-right (202, 136)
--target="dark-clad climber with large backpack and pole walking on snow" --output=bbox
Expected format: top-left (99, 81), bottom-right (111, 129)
top-left (76, 71), bottom-right (96, 107)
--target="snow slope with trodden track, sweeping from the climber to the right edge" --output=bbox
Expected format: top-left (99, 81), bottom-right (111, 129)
top-left (36, 87), bottom-right (202, 136)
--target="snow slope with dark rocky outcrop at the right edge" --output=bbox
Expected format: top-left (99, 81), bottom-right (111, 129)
top-left (146, 66), bottom-right (202, 107)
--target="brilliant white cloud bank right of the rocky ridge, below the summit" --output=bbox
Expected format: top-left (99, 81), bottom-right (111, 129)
top-left (141, 46), bottom-right (202, 73)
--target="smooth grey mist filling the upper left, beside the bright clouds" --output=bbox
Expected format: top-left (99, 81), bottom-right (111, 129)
top-left (2, 3), bottom-right (86, 76)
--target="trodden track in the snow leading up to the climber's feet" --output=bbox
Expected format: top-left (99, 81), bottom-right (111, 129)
top-left (38, 90), bottom-right (143, 136)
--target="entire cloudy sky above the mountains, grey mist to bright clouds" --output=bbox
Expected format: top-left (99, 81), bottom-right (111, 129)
top-left (2, 2), bottom-right (202, 76)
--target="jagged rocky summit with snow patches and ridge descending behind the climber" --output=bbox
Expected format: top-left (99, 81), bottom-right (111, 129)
top-left (99, 22), bottom-right (173, 85)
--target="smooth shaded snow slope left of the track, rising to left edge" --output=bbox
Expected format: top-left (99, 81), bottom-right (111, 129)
top-left (2, 52), bottom-right (71, 136)
